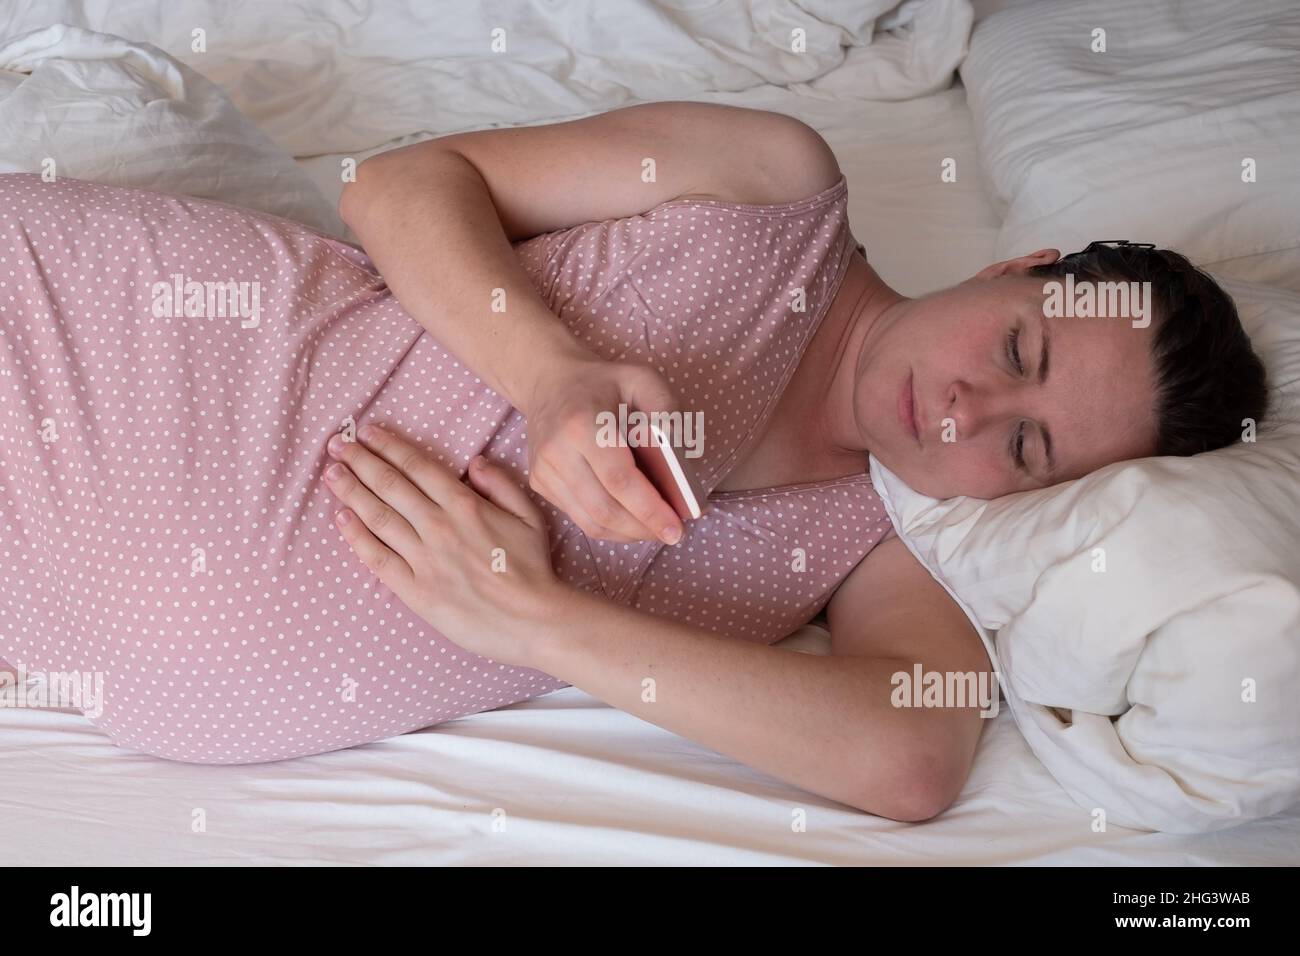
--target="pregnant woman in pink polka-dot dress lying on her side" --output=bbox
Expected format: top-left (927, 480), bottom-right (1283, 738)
top-left (0, 103), bottom-right (1265, 821)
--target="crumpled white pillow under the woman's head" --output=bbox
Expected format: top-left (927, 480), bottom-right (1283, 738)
top-left (871, 277), bottom-right (1300, 832)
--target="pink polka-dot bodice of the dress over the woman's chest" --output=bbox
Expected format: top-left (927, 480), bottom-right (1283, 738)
top-left (525, 177), bottom-right (892, 644)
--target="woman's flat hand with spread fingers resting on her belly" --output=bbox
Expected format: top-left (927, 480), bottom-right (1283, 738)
top-left (325, 425), bottom-right (572, 667)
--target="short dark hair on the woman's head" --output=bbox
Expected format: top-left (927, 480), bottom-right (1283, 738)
top-left (1027, 243), bottom-right (1269, 455)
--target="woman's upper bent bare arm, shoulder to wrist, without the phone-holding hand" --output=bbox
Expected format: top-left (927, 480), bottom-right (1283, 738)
top-left (339, 103), bottom-right (839, 414)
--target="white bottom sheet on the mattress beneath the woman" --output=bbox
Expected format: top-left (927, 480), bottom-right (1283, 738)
top-left (0, 26), bottom-right (1300, 865)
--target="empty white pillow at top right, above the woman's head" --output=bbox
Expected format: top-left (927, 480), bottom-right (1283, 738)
top-left (961, 0), bottom-right (1300, 291)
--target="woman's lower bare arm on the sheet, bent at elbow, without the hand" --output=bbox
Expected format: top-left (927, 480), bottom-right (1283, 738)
top-left (533, 538), bottom-right (996, 821)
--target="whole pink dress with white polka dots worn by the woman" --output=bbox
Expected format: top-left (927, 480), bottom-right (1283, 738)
top-left (0, 174), bottom-right (891, 763)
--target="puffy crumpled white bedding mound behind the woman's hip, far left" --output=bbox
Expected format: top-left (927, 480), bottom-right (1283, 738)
top-left (0, 25), bottom-right (343, 235)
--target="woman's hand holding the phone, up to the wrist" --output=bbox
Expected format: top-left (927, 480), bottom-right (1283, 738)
top-left (523, 359), bottom-right (683, 545)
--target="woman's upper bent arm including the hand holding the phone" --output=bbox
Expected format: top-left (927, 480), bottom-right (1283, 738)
top-left (339, 103), bottom-right (840, 544)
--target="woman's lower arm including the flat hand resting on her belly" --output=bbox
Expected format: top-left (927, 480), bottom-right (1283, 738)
top-left (322, 432), bottom-right (988, 821)
